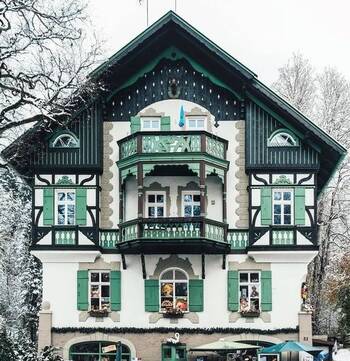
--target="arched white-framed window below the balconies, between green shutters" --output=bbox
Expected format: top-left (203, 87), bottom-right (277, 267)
top-left (159, 268), bottom-right (188, 312)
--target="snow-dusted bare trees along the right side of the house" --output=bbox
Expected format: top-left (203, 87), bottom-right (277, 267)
top-left (273, 54), bottom-right (350, 333)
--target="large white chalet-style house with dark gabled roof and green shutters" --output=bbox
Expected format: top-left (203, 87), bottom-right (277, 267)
top-left (3, 12), bottom-right (345, 361)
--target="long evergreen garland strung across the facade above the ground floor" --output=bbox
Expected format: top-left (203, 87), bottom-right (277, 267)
top-left (51, 327), bottom-right (299, 335)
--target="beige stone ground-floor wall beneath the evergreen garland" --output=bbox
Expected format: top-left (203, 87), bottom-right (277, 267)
top-left (51, 329), bottom-right (299, 361)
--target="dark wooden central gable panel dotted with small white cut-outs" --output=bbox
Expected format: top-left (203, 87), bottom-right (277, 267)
top-left (105, 58), bottom-right (244, 121)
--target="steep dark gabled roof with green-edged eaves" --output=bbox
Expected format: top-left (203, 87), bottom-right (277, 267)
top-left (4, 11), bottom-right (346, 188)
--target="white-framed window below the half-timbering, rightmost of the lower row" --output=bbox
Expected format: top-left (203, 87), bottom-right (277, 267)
top-left (239, 271), bottom-right (260, 313)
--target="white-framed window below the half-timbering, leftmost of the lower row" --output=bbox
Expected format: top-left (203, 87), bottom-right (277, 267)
top-left (89, 270), bottom-right (111, 311)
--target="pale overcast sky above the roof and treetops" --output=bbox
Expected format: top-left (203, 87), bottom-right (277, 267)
top-left (89, 0), bottom-right (350, 85)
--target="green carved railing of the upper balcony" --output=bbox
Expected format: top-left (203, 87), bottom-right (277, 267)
top-left (118, 131), bottom-right (227, 161)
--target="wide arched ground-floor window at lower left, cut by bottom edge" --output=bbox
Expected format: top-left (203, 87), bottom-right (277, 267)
top-left (69, 341), bottom-right (131, 361)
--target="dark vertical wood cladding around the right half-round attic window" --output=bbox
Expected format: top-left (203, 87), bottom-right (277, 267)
top-left (246, 100), bottom-right (320, 170)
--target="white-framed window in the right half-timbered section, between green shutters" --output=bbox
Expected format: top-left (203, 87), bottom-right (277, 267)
top-left (272, 189), bottom-right (293, 225)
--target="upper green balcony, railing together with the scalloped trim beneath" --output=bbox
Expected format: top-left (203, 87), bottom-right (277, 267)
top-left (118, 131), bottom-right (229, 175)
